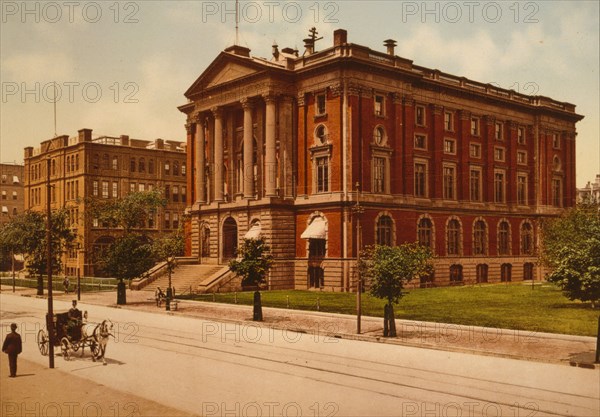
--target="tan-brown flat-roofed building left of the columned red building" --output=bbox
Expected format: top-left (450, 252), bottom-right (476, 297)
top-left (25, 129), bottom-right (188, 275)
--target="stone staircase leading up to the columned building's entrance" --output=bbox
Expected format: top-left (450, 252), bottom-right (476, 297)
top-left (142, 264), bottom-right (229, 294)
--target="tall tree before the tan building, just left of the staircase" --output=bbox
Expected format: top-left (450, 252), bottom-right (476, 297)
top-left (87, 190), bottom-right (167, 304)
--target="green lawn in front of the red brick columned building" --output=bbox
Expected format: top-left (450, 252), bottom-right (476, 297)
top-left (186, 283), bottom-right (600, 336)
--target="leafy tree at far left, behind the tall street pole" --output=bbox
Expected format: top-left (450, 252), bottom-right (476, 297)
top-left (0, 209), bottom-right (75, 295)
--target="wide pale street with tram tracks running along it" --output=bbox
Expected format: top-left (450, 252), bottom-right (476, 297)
top-left (0, 294), bottom-right (600, 416)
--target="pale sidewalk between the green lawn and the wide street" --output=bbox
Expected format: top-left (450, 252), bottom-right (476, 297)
top-left (2, 286), bottom-right (600, 369)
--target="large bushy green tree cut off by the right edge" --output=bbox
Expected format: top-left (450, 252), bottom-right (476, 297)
top-left (541, 201), bottom-right (600, 308)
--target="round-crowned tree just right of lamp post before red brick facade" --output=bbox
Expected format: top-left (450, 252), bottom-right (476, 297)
top-left (359, 243), bottom-right (433, 337)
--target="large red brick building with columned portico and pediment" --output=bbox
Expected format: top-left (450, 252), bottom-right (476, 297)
top-left (179, 29), bottom-right (582, 291)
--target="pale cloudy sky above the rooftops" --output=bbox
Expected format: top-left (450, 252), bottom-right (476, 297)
top-left (0, 0), bottom-right (600, 187)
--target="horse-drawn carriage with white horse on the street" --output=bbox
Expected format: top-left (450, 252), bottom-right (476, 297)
top-left (37, 310), bottom-right (113, 365)
